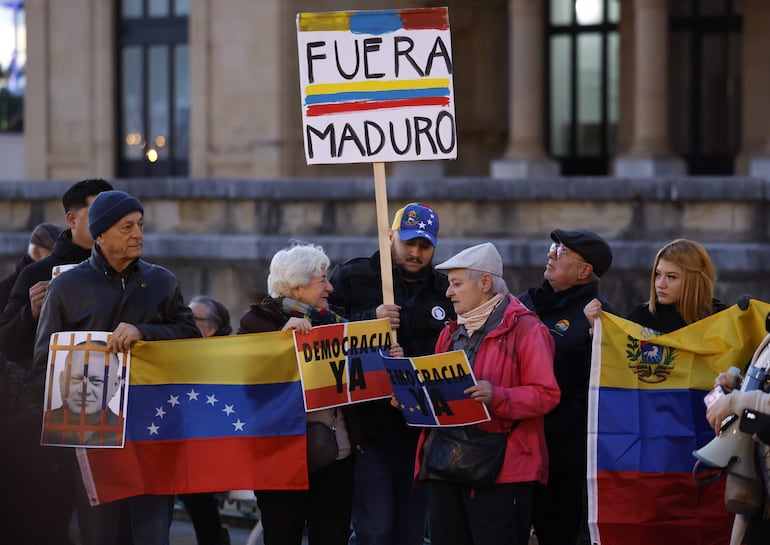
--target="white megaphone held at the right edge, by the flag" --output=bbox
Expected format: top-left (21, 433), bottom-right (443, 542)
top-left (692, 416), bottom-right (758, 479)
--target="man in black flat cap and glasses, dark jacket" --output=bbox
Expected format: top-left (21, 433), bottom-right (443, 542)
top-left (519, 229), bottom-right (613, 545)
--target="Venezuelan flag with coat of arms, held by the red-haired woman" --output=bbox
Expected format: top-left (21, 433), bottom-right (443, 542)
top-left (588, 300), bottom-right (770, 545)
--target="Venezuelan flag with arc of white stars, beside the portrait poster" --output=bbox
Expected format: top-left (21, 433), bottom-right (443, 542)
top-left (78, 331), bottom-right (308, 505)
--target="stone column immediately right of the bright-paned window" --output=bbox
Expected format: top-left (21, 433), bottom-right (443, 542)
top-left (615, 0), bottom-right (686, 176)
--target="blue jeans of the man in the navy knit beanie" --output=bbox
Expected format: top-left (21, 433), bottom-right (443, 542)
top-left (77, 485), bottom-right (174, 545)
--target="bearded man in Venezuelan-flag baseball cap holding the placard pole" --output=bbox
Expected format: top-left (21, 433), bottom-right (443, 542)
top-left (329, 202), bottom-right (455, 545)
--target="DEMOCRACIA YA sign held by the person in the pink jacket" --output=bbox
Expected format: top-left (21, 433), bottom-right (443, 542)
top-left (382, 350), bottom-right (490, 426)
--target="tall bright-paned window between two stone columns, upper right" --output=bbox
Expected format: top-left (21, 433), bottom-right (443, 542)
top-left (546, 0), bottom-right (620, 175)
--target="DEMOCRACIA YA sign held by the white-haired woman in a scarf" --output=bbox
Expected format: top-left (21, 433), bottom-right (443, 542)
top-left (294, 320), bottom-right (392, 412)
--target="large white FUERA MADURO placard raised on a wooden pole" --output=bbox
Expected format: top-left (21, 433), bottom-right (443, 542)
top-left (297, 8), bottom-right (450, 164)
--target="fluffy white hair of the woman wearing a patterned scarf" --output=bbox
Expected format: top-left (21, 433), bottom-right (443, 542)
top-left (267, 242), bottom-right (330, 297)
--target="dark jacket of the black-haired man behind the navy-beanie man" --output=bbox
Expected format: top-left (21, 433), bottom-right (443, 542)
top-left (0, 229), bottom-right (91, 369)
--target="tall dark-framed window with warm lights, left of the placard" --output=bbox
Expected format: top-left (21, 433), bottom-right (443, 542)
top-left (117, 0), bottom-right (190, 177)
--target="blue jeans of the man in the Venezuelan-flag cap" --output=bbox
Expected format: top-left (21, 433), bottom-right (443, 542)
top-left (349, 444), bottom-right (428, 545)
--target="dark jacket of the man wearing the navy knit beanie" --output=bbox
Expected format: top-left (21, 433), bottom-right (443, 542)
top-left (23, 244), bottom-right (200, 408)
